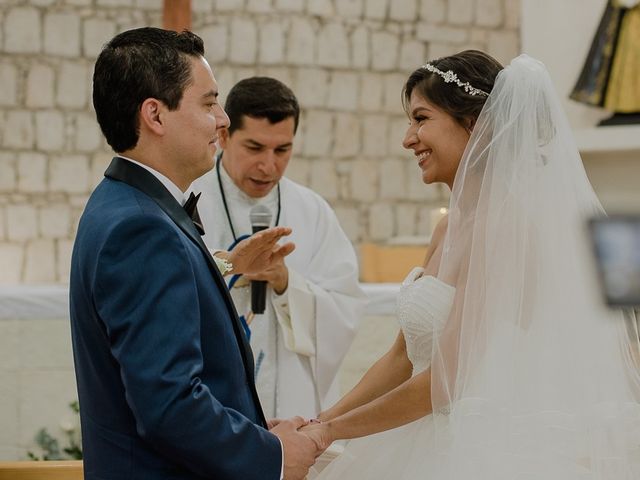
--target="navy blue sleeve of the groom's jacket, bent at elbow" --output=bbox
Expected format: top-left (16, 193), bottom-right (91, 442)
top-left (94, 215), bottom-right (282, 480)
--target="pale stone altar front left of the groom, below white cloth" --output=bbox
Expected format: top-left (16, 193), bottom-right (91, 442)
top-left (0, 318), bottom-right (78, 461)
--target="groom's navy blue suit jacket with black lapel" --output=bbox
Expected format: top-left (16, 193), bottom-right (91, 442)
top-left (70, 157), bottom-right (282, 480)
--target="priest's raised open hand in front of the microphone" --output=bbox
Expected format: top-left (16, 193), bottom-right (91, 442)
top-left (216, 227), bottom-right (296, 276)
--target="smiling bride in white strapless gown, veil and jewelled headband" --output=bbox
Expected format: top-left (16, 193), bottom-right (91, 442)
top-left (306, 51), bottom-right (640, 480)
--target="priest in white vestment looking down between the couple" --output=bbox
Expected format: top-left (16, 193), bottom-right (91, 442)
top-left (191, 77), bottom-right (365, 418)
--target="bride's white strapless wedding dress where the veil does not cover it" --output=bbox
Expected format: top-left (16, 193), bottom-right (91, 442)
top-left (310, 267), bottom-right (455, 480)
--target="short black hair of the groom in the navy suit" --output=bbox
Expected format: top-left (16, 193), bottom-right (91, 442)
top-left (93, 27), bottom-right (204, 152)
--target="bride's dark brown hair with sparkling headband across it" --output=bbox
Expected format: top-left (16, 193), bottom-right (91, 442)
top-left (402, 50), bottom-right (504, 125)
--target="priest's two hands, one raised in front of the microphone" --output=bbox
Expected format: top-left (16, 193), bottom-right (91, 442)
top-left (216, 227), bottom-right (295, 294)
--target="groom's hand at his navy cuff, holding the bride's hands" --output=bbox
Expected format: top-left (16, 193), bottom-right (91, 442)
top-left (269, 417), bottom-right (319, 480)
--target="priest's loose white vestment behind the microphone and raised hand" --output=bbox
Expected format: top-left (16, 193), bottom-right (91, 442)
top-left (190, 164), bottom-right (366, 418)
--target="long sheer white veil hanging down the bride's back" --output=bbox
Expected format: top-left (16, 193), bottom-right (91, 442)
top-left (431, 55), bottom-right (640, 480)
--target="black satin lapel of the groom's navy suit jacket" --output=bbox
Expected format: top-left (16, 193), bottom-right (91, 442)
top-left (104, 157), bottom-right (266, 425)
